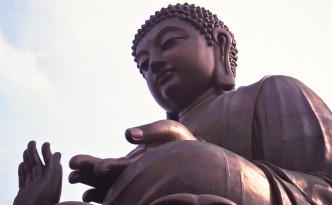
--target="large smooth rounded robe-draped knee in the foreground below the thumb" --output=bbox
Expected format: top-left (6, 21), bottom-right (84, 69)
top-left (104, 141), bottom-right (330, 205)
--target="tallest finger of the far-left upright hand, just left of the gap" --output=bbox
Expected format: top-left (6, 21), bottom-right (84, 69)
top-left (28, 141), bottom-right (43, 179)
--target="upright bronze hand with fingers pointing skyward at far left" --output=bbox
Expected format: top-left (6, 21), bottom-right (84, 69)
top-left (14, 141), bottom-right (62, 205)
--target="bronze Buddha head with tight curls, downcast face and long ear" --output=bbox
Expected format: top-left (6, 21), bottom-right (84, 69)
top-left (132, 3), bottom-right (237, 118)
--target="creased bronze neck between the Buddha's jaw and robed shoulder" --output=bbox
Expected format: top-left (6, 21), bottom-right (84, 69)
top-left (179, 88), bottom-right (218, 123)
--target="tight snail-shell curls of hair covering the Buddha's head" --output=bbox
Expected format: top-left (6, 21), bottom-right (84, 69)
top-left (131, 3), bottom-right (238, 77)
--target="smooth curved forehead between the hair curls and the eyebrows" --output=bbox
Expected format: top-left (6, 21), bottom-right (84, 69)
top-left (136, 17), bottom-right (196, 53)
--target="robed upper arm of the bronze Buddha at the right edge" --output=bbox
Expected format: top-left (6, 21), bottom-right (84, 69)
top-left (254, 76), bottom-right (332, 171)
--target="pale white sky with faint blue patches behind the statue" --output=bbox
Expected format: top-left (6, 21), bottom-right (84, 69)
top-left (0, 0), bottom-right (332, 204)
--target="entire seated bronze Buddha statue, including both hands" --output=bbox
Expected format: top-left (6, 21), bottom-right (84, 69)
top-left (14, 3), bottom-right (332, 205)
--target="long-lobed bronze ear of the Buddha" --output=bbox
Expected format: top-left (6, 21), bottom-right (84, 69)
top-left (212, 27), bottom-right (235, 91)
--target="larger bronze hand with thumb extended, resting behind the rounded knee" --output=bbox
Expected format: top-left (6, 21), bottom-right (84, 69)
top-left (69, 120), bottom-right (196, 203)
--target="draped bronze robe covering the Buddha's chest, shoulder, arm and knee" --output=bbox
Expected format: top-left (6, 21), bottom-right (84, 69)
top-left (104, 76), bottom-right (332, 205)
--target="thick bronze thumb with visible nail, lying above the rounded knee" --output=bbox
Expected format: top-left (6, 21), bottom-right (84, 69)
top-left (125, 120), bottom-right (196, 144)
